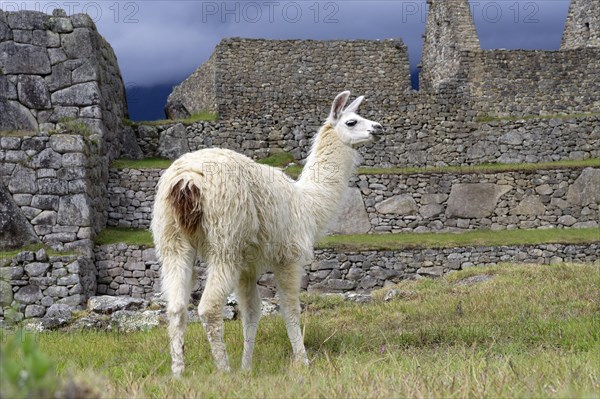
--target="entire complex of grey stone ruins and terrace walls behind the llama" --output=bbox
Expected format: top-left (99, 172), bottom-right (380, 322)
top-left (0, 0), bottom-right (600, 321)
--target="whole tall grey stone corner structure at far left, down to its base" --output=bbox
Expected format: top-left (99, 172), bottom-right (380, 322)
top-left (0, 10), bottom-right (127, 318)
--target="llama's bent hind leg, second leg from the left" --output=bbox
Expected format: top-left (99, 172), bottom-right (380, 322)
top-left (198, 265), bottom-right (239, 372)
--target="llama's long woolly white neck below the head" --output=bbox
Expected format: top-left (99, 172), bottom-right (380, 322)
top-left (298, 123), bottom-right (356, 234)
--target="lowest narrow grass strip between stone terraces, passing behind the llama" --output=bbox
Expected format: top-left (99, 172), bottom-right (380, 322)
top-left (96, 228), bottom-right (600, 251)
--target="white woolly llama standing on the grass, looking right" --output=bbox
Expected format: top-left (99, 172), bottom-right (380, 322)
top-left (151, 91), bottom-right (383, 376)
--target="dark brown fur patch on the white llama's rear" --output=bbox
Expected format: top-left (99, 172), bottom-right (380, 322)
top-left (169, 181), bottom-right (202, 236)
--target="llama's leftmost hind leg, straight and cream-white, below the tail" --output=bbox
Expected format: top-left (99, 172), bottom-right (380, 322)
top-left (161, 246), bottom-right (196, 377)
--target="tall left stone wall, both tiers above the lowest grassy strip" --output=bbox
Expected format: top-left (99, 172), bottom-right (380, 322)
top-left (0, 9), bottom-right (127, 251)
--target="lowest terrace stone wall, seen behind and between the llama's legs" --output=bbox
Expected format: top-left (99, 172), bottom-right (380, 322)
top-left (90, 244), bottom-right (600, 301)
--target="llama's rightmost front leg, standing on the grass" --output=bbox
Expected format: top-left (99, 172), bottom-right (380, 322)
top-left (275, 265), bottom-right (309, 365)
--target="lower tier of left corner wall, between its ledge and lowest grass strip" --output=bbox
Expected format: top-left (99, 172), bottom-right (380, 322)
top-left (0, 132), bottom-right (101, 250)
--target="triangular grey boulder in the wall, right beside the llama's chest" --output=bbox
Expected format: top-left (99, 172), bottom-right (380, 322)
top-left (328, 188), bottom-right (371, 234)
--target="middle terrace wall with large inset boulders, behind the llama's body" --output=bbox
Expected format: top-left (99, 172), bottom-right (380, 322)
top-left (108, 168), bottom-right (600, 234)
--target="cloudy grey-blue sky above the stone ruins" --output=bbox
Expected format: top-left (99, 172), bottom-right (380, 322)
top-left (0, 0), bottom-right (569, 120)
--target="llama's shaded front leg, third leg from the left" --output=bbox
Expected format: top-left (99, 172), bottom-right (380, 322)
top-left (237, 272), bottom-right (261, 370)
